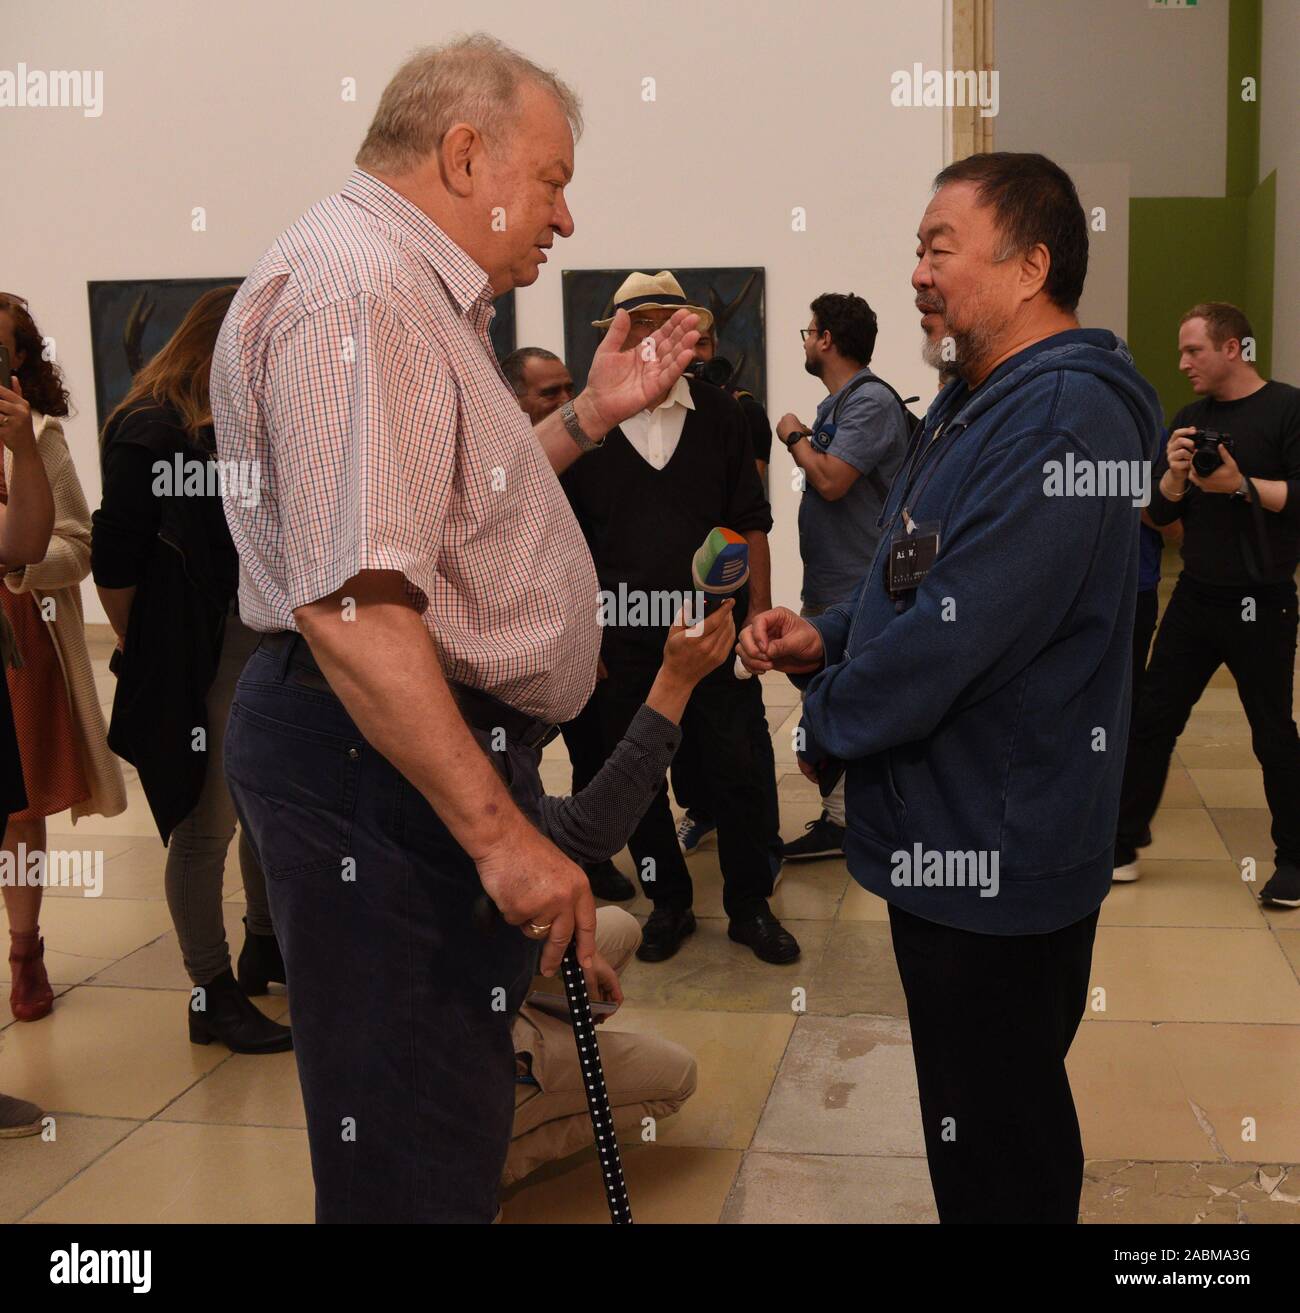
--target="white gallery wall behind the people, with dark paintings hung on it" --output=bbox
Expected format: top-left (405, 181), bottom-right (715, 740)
top-left (0, 0), bottom-right (943, 621)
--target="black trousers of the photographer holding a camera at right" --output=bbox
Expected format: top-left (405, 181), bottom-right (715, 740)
top-left (1115, 576), bottom-right (1300, 864)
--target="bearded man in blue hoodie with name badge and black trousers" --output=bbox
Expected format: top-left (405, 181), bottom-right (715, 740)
top-left (738, 152), bottom-right (1161, 1222)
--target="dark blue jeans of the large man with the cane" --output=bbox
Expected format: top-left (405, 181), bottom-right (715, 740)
top-left (226, 639), bottom-right (540, 1222)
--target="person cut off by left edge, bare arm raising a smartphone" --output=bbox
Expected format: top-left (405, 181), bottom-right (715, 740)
top-left (0, 341), bottom-right (54, 1138)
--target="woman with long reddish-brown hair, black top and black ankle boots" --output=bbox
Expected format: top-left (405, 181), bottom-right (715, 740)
top-left (92, 286), bottom-right (292, 1053)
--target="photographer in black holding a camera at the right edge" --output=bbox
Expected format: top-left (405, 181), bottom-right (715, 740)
top-left (1115, 301), bottom-right (1300, 907)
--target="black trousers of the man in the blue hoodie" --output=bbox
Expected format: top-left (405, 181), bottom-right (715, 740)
top-left (889, 905), bottom-right (1096, 1222)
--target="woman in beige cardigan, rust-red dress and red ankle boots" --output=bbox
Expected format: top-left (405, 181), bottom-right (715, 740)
top-left (0, 293), bottom-right (126, 1022)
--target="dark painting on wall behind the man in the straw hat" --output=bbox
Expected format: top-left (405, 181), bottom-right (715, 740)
top-left (562, 264), bottom-right (767, 406)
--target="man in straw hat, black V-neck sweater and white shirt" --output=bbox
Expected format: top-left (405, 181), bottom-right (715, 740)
top-left (562, 269), bottom-right (798, 962)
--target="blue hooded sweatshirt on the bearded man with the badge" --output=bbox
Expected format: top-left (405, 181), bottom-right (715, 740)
top-left (800, 328), bottom-right (1161, 935)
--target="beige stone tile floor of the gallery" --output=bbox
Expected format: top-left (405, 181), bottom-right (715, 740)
top-left (0, 596), bottom-right (1300, 1222)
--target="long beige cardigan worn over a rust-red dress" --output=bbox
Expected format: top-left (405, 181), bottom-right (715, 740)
top-left (4, 411), bottom-right (126, 821)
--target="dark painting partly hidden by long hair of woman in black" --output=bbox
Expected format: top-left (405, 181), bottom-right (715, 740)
top-left (87, 274), bottom-right (243, 429)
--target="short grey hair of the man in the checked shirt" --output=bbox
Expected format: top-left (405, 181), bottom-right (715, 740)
top-left (356, 32), bottom-right (582, 173)
